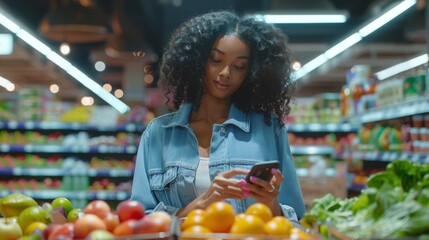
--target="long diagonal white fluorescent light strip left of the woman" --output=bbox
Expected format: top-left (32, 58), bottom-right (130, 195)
top-left (0, 7), bottom-right (130, 113)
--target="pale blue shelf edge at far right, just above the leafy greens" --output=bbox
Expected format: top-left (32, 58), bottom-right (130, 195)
top-left (338, 151), bottom-right (429, 163)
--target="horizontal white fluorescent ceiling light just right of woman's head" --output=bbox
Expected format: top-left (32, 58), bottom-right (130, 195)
top-left (257, 14), bottom-right (347, 24)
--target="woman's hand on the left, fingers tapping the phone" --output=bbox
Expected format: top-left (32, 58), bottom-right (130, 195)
top-left (198, 168), bottom-right (249, 208)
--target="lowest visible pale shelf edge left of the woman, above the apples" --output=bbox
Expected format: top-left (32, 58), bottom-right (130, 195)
top-left (0, 167), bottom-right (133, 177)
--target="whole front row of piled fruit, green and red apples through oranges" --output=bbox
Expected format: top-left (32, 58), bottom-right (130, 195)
top-left (0, 193), bottom-right (319, 240)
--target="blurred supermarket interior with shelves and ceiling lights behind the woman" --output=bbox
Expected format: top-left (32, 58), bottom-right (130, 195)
top-left (0, 0), bottom-right (429, 208)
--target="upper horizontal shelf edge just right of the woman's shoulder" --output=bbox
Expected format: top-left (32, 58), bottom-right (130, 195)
top-left (287, 123), bottom-right (359, 133)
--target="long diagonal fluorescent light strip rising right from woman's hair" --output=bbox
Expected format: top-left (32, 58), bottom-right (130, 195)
top-left (293, 0), bottom-right (416, 81)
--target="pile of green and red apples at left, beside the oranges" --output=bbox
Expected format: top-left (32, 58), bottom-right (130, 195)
top-left (0, 193), bottom-right (172, 240)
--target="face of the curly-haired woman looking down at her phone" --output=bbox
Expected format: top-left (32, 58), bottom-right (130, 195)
top-left (204, 35), bottom-right (250, 99)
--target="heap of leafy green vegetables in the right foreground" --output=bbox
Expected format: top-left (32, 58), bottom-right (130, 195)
top-left (301, 160), bottom-right (429, 239)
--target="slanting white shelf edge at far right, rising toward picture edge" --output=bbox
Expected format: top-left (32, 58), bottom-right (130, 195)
top-left (345, 96), bottom-right (429, 124)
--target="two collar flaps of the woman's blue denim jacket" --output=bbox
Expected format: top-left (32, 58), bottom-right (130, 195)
top-left (164, 103), bottom-right (252, 132)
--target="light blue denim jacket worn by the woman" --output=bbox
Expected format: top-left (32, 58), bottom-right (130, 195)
top-left (131, 104), bottom-right (305, 220)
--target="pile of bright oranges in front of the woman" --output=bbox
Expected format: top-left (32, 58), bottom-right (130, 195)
top-left (180, 202), bottom-right (316, 239)
